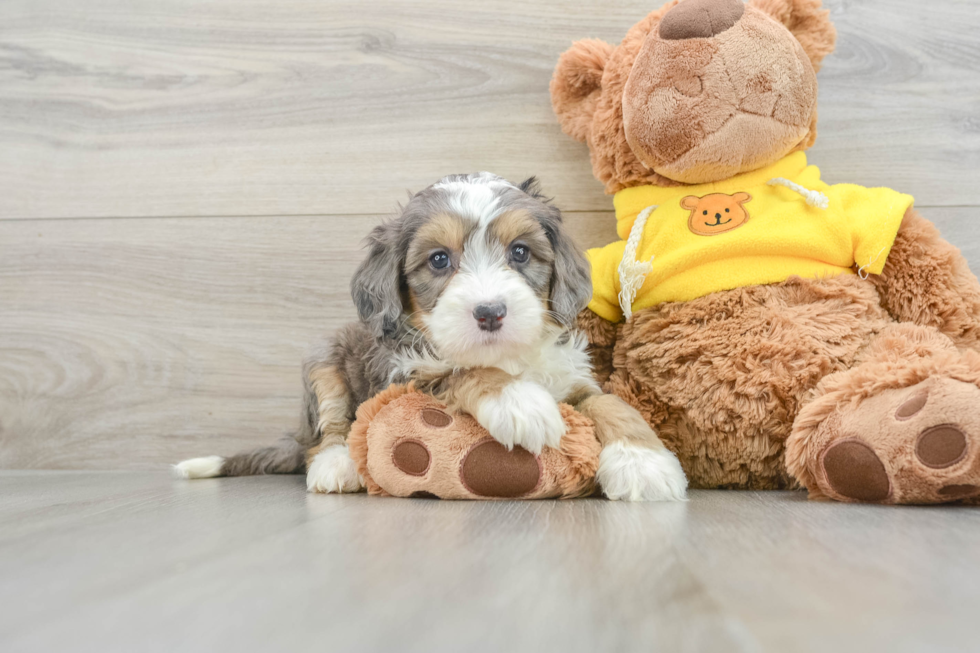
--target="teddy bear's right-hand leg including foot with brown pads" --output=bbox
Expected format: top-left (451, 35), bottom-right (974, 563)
top-left (786, 324), bottom-right (980, 504)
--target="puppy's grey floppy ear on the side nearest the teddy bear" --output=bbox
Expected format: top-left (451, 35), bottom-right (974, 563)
top-left (543, 207), bottom-right (592, 327)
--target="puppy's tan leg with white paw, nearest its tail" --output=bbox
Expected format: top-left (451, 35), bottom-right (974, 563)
top-left (305, 365), bottom-right (364, 493)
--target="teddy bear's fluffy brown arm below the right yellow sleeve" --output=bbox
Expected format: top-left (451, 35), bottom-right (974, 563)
top-left (870, 209), bottom-right (980, 351)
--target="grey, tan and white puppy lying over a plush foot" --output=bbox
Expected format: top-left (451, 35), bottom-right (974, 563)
top-left (175, 173), bottom-right (687, 501)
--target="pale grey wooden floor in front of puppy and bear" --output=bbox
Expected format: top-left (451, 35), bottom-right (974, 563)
top-left (0, 472), bottom-right (980, 653)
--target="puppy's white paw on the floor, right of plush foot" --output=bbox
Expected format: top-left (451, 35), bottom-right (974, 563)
top-left (596, 442), bottom-right (687, 501)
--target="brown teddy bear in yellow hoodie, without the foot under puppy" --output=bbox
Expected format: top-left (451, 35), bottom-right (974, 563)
top-left (551, 0), bottom-right (980, 504)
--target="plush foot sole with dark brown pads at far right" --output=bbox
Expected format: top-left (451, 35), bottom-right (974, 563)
top-left (814, 378), bottom-right (980, 503)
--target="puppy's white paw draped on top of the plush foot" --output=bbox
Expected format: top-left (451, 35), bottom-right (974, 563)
top-left (475, 381), bottom-right (568, 455)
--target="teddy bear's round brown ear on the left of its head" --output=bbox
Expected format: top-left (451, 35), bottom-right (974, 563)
top-left (551, 39), bottom-right (613, 141)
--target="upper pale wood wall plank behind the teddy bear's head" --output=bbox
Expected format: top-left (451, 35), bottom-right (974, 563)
top-left (0, 0), bottom-right (980, 218)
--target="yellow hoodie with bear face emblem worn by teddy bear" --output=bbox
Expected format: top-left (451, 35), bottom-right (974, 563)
top-left (587, 152), bottom-right (914, 322)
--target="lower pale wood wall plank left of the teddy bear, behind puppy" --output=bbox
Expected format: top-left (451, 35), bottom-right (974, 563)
top-left (0, 213), bottom-right (615, 469)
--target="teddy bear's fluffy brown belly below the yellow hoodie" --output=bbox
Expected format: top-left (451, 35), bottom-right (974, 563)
top-left (593, 276), bottom-right (887, 489)
